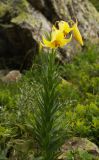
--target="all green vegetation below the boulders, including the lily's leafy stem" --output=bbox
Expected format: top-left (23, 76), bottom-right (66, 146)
top-left (0, 46), bottom-right (99, 160)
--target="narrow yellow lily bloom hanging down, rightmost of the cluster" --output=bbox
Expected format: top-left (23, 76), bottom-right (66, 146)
top-left (73, 22), bottom-right (83, 46)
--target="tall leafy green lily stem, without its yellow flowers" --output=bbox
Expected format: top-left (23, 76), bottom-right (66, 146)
top-left (32, 52), bottom-right (63, 160)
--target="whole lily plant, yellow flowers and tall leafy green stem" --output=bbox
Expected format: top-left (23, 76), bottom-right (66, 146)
top-left (34, 21), bottom-right (83, 160)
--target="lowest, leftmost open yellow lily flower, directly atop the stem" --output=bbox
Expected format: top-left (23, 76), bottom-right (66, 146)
top-left (42, 29), bottom-right (72, 48)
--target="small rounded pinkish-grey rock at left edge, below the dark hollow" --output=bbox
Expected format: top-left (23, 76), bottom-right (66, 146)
top-left (1, 70), bottom-right (22, 83)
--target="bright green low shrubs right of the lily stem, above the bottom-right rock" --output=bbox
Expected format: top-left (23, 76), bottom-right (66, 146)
top-left (60, 44), bottom-right (99, 145)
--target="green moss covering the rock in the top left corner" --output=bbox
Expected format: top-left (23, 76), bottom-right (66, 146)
top-left (0, 0), bottom-right (35, 27)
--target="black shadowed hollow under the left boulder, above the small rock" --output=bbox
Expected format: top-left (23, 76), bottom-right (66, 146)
top-left (0, 24), bottom-right (38, 70)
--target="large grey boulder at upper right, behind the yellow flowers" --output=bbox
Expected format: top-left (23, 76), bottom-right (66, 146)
top-left (28, 0), bottom-right (99, 62)
